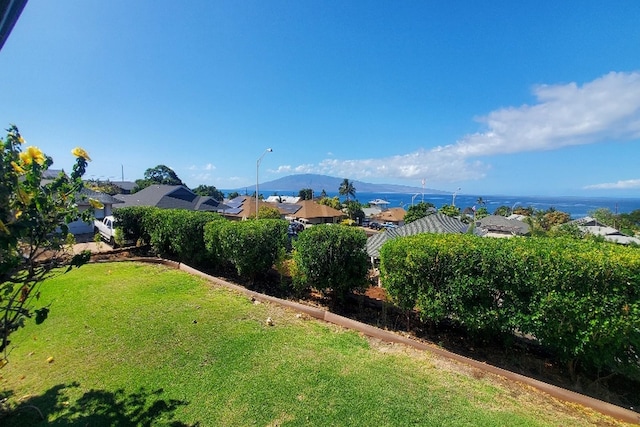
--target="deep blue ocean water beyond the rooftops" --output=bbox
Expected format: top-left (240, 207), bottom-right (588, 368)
top-left (316, 193), bottom-right (640, 219)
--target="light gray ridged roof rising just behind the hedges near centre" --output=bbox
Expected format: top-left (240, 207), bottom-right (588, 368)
top-left (367, 213), bottom-right (465, 258)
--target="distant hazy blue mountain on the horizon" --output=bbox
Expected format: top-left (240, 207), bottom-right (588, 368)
top-left (248, 173), bottom-right (449, 194)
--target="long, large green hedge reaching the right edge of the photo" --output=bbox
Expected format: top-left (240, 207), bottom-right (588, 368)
top-left (380, 234), bottom-right (640, 379)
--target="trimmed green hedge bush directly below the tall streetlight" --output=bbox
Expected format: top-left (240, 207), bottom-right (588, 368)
top-left (205, 219), bottom-right (288, 280)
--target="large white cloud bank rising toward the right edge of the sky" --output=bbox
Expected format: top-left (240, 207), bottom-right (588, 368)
top-left (277, 72), bottom-right (640, 185)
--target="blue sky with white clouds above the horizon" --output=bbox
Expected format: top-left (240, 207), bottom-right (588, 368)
top-left (0, 0), bottom-right (640, 197)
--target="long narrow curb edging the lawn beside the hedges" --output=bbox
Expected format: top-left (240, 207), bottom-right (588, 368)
top-left (102, 258), bottom-right (640, 424)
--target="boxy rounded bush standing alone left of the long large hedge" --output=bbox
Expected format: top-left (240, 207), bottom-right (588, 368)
top-left (293, 225), bottom-right (369, 302)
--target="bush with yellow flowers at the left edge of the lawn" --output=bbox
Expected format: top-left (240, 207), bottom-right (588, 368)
top-left (0, 125), bottom-right (94, 366)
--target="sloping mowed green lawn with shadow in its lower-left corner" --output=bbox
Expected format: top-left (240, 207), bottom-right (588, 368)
top-left (0, 263), bottom-right (622, 426)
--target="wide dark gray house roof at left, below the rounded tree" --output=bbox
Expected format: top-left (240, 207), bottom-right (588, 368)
top-left (116, 185), bottom-right (228, 212)
